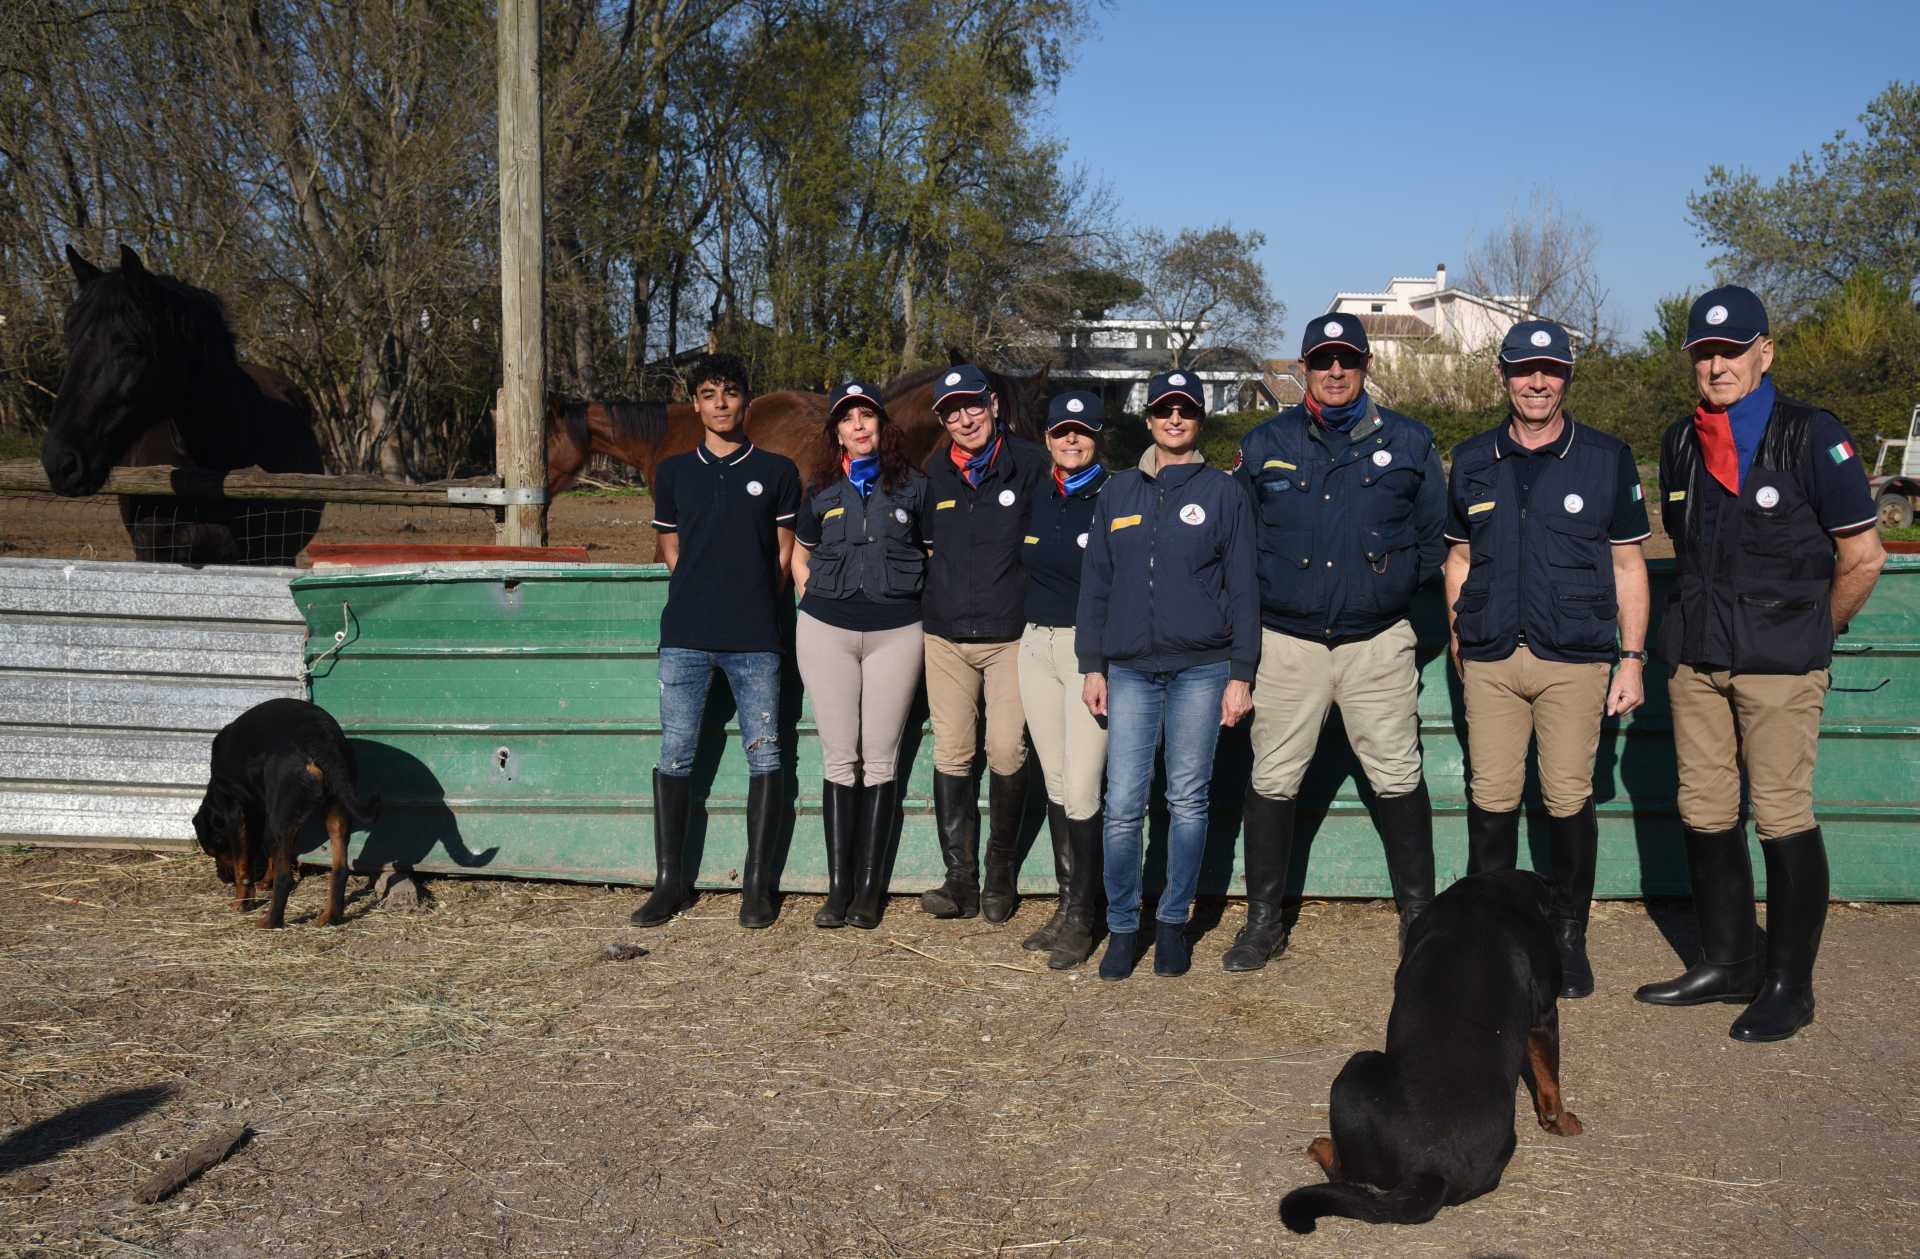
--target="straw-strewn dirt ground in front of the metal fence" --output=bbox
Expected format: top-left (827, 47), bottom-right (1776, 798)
top-left (0, 848), bottom-right (1920, 1259)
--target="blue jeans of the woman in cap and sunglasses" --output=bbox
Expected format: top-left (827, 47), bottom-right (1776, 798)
top-left (1104, 660), bottom-right (1231, 931)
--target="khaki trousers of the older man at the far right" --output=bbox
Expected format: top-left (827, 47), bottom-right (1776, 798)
top-left (1667, 664), bottom-right (1830, 839)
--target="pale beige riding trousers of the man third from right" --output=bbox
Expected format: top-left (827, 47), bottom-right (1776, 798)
top-left (1252, 620), bottom-right (1421, 800)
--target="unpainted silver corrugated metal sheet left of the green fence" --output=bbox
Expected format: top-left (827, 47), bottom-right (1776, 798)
top-left (0, 560), bottom-right (305, 843)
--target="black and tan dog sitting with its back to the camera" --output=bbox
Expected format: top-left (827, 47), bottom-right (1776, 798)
top-left (1281, 869), bottom-right (1580, 1232)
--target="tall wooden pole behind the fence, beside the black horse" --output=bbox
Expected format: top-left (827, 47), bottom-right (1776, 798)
top-left (493, 0), bottom-right (547, 547)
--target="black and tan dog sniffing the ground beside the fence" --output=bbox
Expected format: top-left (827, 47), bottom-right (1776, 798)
top-left (194, 699), bottom-right (380, 927)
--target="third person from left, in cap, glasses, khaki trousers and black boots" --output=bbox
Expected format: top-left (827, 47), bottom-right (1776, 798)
top-left (920, 365), bottom-right (1050, 923)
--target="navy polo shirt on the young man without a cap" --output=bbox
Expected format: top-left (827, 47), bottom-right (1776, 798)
top-left (653, 443), bottom-right (801, 651)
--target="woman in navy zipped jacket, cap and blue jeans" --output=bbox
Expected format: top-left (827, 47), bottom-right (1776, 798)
top-left (1075, 370), bottom-right (1260, 979)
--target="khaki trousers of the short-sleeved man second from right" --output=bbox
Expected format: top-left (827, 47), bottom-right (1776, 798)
top-left (1461, 647), bottom-right (1613, 818)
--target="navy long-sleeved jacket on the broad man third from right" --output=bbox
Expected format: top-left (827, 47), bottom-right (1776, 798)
top-left (1235, 401), bottom-right (1446, 643)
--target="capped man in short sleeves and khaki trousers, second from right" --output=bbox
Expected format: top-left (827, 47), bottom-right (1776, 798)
top-left (1446, 319), bottom-right (1649, 996)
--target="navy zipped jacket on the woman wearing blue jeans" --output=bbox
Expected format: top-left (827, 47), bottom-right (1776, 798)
top-left (1073, 447), bottom-right (1260, 681)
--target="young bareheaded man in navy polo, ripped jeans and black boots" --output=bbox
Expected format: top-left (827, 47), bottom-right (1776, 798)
top-left (634, 355), bottom-right (801, 927)
